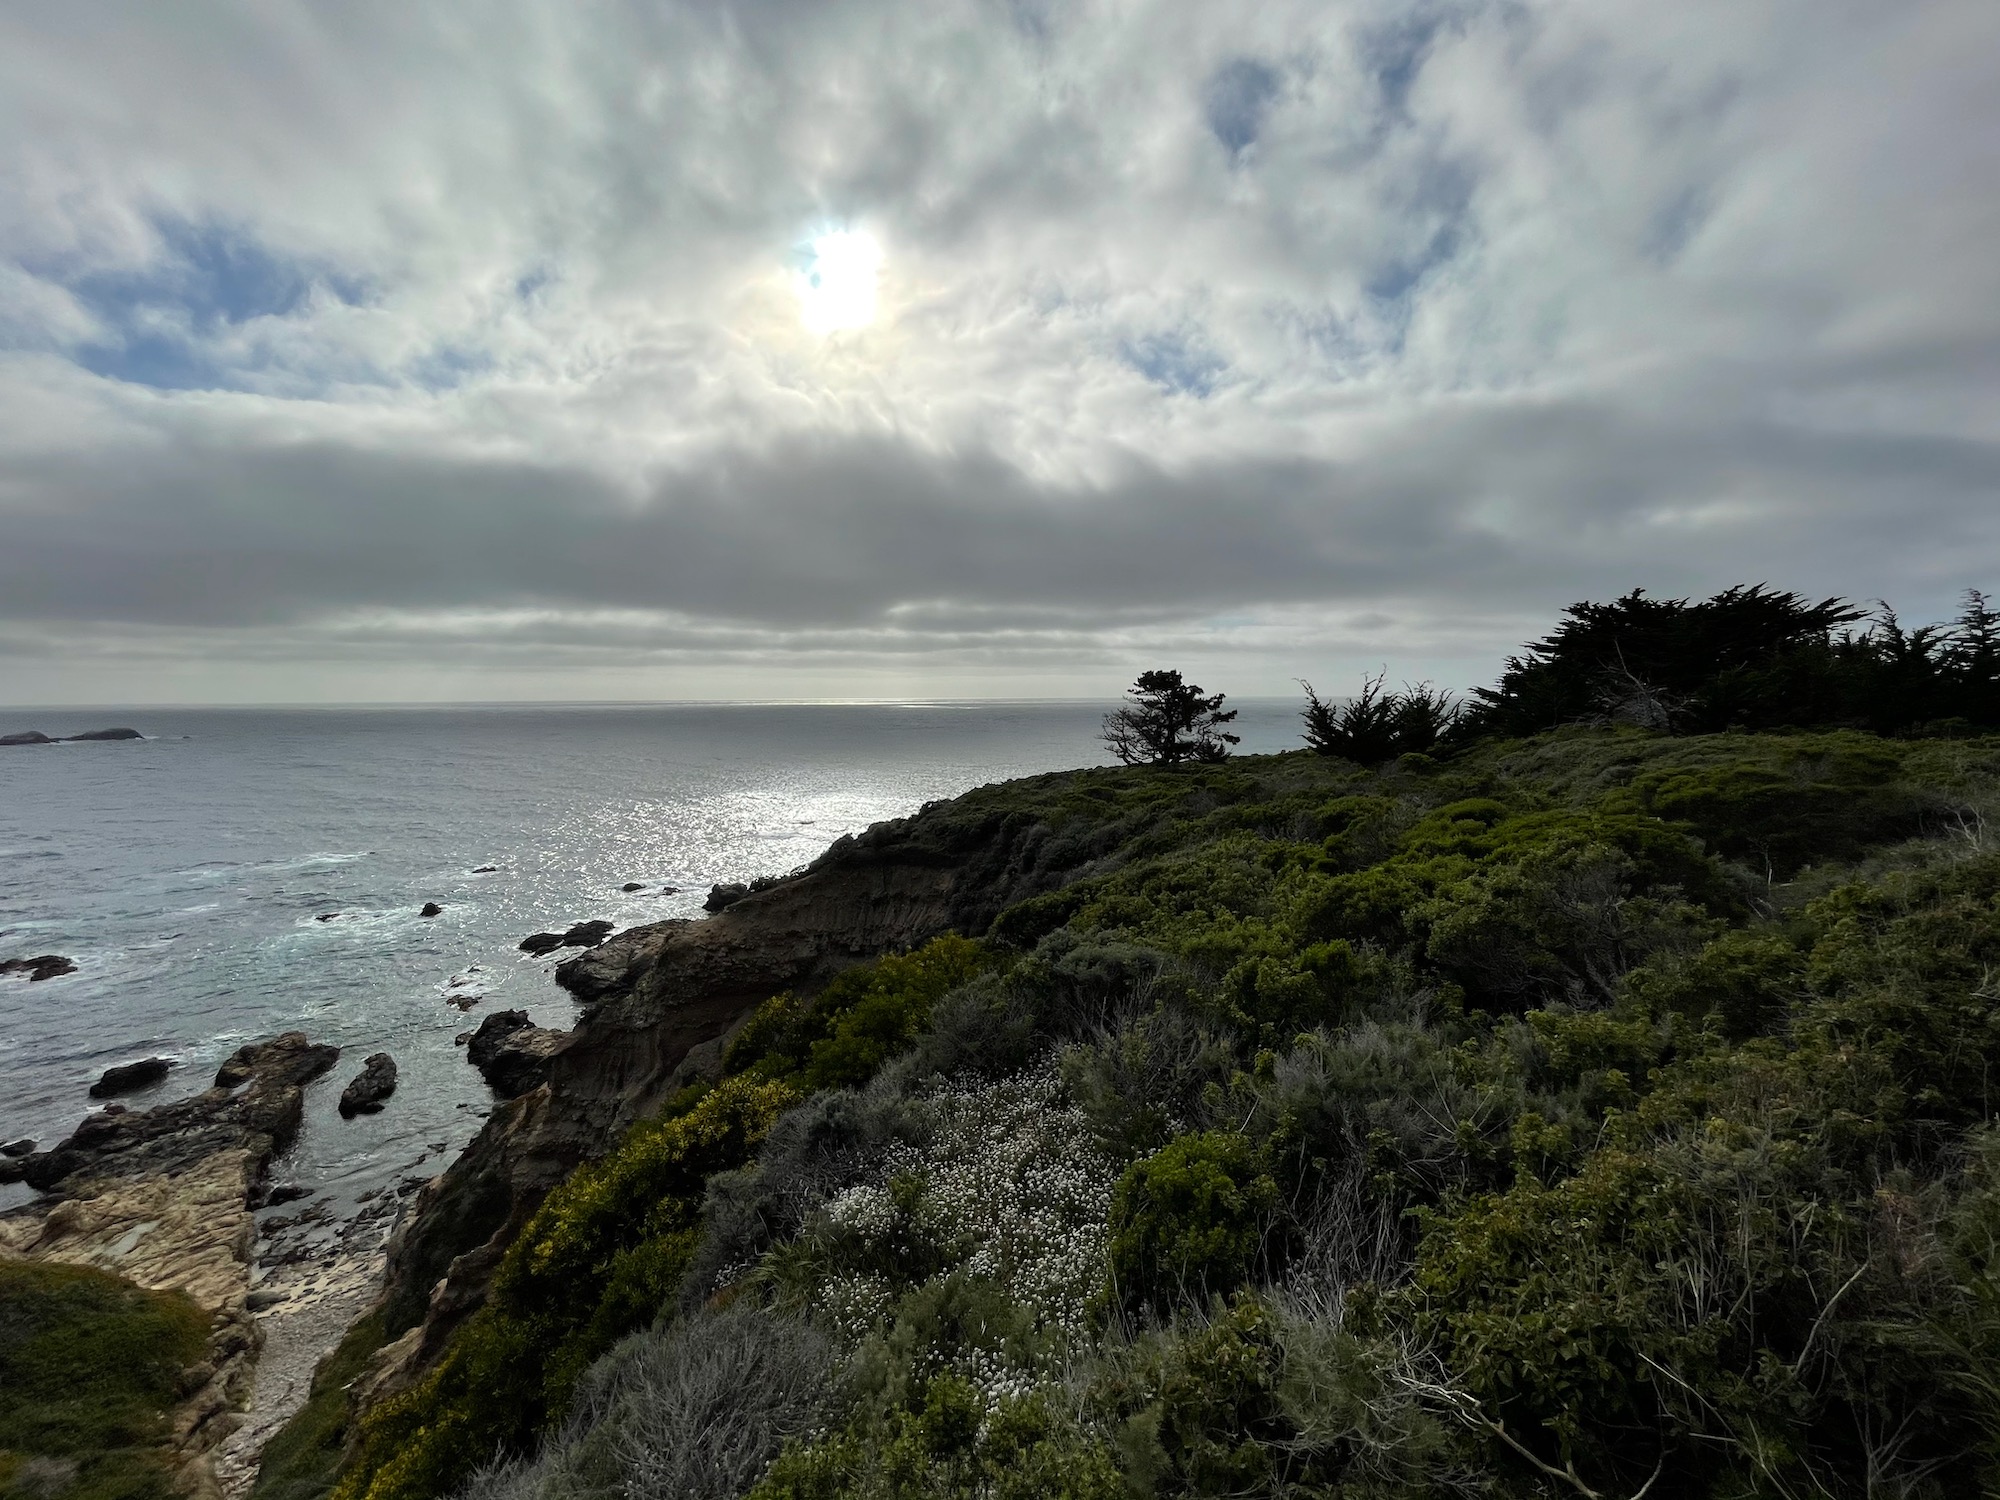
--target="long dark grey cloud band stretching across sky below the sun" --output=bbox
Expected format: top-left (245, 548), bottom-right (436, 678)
top-left (0, 406), bottom-right (2000, 630)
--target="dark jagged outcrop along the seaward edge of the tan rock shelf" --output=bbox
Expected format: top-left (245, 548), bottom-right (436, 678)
top-left (20, 1032), bottom-right (340, 1192)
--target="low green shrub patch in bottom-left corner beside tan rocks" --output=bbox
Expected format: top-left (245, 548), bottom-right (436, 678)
top-left (0, 1260), bottom-right (208, 1500)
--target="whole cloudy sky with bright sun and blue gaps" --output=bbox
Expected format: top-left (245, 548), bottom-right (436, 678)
top-left (0, 0), bottom-right (2000, 704)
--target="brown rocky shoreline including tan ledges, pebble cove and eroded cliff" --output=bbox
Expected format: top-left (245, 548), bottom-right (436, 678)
top-left (0, 788), bottom-right (1094, 1500)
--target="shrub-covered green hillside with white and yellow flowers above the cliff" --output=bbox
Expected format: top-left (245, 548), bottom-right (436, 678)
top-left (312, 728), bottom-right (2000, 1500)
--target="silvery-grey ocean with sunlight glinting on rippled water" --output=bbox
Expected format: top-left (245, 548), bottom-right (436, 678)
top-left (0, 700), bottom-right (1298, 1208)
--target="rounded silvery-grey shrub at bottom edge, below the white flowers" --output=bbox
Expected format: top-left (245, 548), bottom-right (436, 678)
top-left (462, 1302), bottom-right (836, 1500)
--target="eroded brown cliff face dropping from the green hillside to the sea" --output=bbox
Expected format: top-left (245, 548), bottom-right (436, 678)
top-left (370, 778), bottom-right (1116, 1394)
